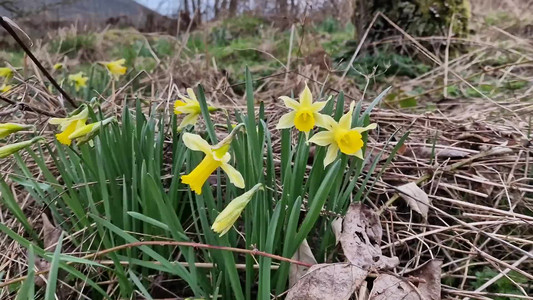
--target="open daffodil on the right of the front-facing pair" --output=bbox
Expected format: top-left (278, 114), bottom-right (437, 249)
top-left (309, 102), bottom-right (377, 167)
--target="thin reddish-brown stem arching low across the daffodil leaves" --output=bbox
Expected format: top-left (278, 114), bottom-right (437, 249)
top-left (0, 241), bottom-right (312, 288)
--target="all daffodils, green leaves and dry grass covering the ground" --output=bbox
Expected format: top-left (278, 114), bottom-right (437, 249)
top-left (0, 1), bottom-right (533, 299)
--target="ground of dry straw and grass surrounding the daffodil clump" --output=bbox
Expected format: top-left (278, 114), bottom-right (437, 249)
top-left (0, 1), bottom-right (533, 299)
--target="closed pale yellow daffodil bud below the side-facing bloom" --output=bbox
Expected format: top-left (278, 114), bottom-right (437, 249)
top-left (211, 183), bottom-right (263, 236)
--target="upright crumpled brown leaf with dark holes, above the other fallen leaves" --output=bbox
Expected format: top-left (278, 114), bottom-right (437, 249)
top-left (340, 203), bottom-right (399, 270)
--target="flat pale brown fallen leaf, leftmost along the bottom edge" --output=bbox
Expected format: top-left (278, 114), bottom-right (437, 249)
top-left (286, 263), bottom-right (368, 300)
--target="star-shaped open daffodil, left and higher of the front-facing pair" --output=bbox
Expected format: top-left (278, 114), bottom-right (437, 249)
top-left (276, 84), bottom-right (326, 137)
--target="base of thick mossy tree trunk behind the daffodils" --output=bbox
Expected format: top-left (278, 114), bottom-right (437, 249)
top-left (353, 0), bottom-right (471, 41)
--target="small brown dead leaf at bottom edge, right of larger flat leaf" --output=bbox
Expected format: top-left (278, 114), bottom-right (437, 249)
top-left (369, 274), bottom-right (425, 300)
